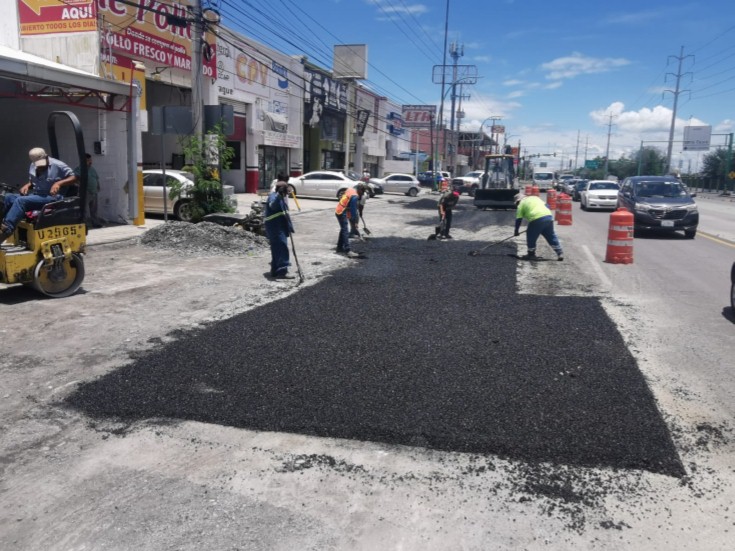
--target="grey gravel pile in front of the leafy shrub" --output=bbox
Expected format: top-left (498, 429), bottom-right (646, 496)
top-left (140, 221), bottom-right (269, 256)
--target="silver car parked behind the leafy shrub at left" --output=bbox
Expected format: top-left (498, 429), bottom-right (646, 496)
top-left (143, 169), bottom-right (237, 222)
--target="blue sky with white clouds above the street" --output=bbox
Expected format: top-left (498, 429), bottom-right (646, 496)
top-left (218, 0), bottom-right (735, 173)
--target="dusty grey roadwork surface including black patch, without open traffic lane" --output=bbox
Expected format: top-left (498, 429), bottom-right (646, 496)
top-left (0, 189), bottom-right (735, 550)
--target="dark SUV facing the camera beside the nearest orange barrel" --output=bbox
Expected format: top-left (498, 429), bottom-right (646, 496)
top-left (617, 176), bottom-right (699, 239)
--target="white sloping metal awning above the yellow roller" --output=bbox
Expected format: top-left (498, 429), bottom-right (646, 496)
top-left (0, 46), bottom-right (131, 96)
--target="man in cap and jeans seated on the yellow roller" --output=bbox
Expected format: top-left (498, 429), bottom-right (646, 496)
top-left (0, 147), bottom-right (77, 248)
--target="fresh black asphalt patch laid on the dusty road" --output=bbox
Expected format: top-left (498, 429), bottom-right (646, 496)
top-left (65, 234), bottom-right (684, 476)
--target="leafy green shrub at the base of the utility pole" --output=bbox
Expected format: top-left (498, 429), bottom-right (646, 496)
top-left (169, 124), bottom-right (235, 222)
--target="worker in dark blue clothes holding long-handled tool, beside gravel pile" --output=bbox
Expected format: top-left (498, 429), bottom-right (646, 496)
top-left (264, 174), bottom-right (294, 279)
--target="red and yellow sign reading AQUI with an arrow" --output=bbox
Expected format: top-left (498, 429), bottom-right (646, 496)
top-left (17, 0), bottom-right (97, 36)
